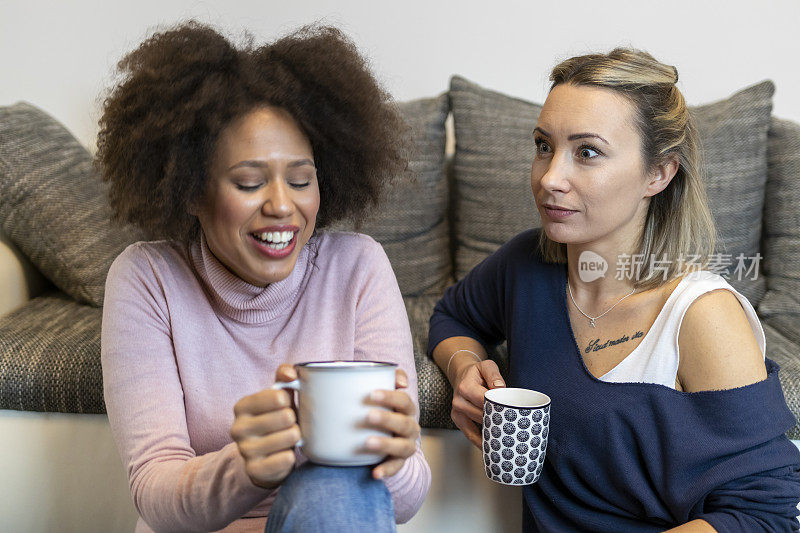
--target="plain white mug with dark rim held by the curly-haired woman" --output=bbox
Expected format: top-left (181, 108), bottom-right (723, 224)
top-left (272, 361), bottom-right (397, 466)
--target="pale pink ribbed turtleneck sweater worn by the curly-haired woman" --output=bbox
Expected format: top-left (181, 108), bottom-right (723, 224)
top-left (102, 232), bottom-right (430, 532)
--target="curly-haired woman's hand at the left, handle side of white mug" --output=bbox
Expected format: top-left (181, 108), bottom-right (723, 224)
top-left (231, 364), bottom-right (300, 489)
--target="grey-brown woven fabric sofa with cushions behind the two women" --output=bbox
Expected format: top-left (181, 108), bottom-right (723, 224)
top-left (0, 76), bottom-right (800, 439)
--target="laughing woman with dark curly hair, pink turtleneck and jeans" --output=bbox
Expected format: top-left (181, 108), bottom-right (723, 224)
top-left (97, 22), bottom-right (430, 531)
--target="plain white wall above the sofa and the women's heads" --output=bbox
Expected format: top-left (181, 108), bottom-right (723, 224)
top-left (0, 0), bottom-right (800, 152)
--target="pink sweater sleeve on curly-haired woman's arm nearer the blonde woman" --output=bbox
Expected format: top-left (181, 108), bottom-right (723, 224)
top-left (354, 237), bottom-right (431, 524)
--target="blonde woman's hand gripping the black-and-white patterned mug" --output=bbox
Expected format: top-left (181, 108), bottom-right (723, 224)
top-left (450, 359), bottom-right (505, 448)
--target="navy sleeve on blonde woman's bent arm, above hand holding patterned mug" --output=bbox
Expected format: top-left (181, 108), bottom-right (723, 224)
top-left (428, 235), bottom-right (514, 355)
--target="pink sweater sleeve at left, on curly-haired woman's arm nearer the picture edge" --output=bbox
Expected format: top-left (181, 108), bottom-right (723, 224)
top-left (101, 245), bottom-right (270, 531)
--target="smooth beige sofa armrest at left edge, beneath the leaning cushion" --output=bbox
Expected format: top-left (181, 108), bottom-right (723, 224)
top-left (0, 229), bottom-right (50, 317)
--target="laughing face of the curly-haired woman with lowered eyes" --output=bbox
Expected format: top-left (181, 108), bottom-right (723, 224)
top-left (196, 107), bottom-right (320, 287)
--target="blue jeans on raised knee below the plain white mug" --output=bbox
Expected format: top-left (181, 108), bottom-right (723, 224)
top-left (264, 462), bottom-right (397, 533)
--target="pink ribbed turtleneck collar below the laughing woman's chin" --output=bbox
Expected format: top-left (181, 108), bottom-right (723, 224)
top-left (189, 231), bottom-right (315, 324)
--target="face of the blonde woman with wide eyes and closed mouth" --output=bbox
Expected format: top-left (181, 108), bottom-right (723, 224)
top-left (531, 84), bottom-right (674, 250)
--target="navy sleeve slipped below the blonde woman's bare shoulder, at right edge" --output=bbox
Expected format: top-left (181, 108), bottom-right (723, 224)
top-left (669, 359), bottom-right (800, 533)
